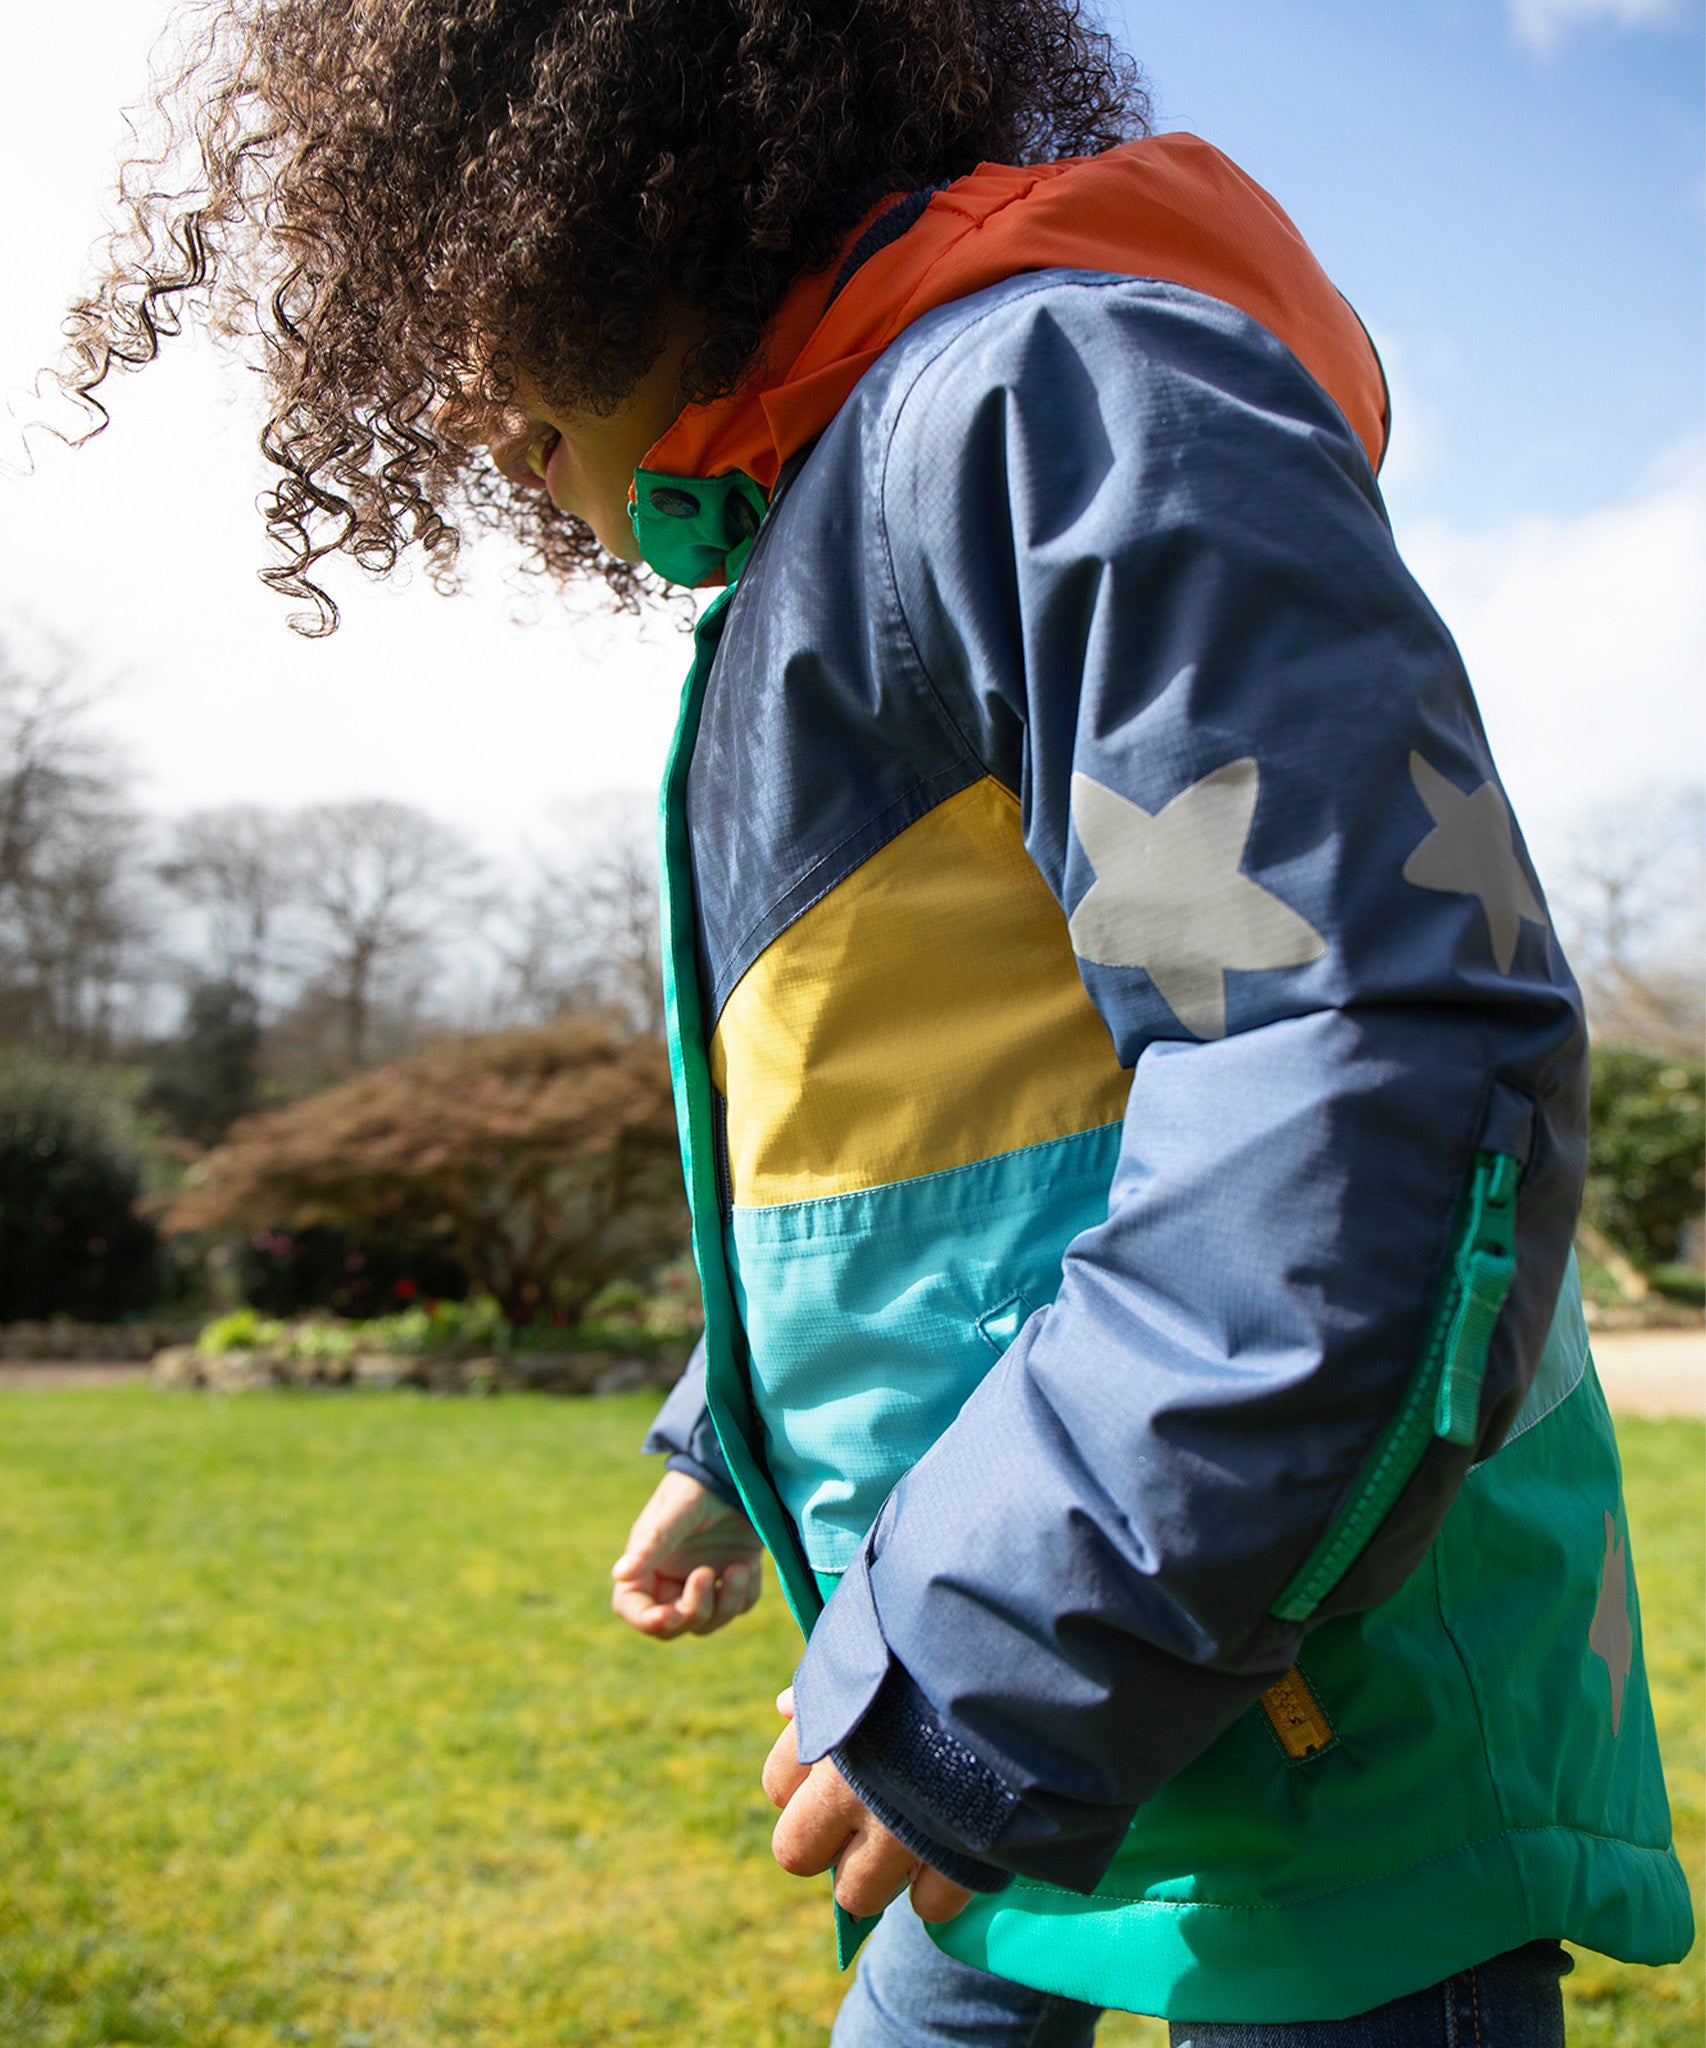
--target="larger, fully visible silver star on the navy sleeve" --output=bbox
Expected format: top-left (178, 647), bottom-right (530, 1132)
top-left (1069, 760), bottom-right (1327, 1038)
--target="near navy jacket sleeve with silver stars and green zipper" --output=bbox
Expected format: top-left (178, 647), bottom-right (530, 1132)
top-left (795, 276), bottom-right (1585, 1890)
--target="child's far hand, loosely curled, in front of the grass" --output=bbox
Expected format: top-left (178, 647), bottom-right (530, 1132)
top-left (610, 1473), bottom-right (764, 1642)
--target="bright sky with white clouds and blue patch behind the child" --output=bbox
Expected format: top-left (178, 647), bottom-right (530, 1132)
top-left (0, 0), bottom-right (1706, 874)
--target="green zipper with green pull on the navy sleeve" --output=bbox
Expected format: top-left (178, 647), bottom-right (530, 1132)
top-left (1268, 1151), bottom-right (1522, 1622)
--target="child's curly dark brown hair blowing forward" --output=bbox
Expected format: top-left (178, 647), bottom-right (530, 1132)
top-left (59, 0), bottom-right (1147, 633)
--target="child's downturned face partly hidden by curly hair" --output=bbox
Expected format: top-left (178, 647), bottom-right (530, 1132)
top-left (487, 322), bottom-right (698, 561)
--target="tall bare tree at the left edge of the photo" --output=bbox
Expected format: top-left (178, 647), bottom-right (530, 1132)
top-left (0, 626), bottom-right (152, 1055)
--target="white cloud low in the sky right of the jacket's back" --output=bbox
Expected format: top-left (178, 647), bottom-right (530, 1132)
top-left (1399, 444), bottom-right (1706, 864)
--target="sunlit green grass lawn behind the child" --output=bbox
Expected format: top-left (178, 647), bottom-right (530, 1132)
top-left (0, 1386), bottom-right (1702, 2048)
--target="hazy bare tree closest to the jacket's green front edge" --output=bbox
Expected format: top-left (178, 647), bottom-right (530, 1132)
top-left (500, 793), bottom-right (664, 1036)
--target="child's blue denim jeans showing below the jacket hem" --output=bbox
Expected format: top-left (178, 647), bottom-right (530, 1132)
top-left (829, 1898), bottom-right (1571, 2048)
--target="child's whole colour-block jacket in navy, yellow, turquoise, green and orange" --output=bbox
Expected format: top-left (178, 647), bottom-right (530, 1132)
top-left (635, 137), bottom-right (1690, 2019)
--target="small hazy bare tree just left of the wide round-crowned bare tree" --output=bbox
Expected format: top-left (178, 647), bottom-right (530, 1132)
top-left (160, 803), bottom-right (303, 1008)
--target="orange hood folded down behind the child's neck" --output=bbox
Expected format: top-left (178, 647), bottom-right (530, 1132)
top-left (643, 135), bottom-right (1387, 492)
